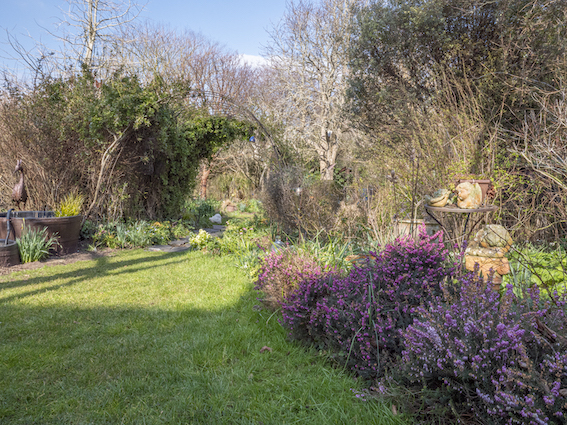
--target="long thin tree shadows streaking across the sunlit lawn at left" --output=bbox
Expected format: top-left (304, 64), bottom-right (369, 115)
top-left (0, 252), bottom-right (188, 303)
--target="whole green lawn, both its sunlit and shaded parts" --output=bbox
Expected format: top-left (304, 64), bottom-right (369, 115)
top-left (0, 250), bottom-right (404, 424)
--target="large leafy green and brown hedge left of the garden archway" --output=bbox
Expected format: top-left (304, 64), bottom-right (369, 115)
top-left (2, 70), bottom-right (250, 220)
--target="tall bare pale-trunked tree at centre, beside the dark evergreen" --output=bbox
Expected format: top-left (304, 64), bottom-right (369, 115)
top-left (266, 0), bottom-right (359, 180)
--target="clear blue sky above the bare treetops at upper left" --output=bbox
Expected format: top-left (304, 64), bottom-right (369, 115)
top-left (0, 0), bottom-right (286, 68)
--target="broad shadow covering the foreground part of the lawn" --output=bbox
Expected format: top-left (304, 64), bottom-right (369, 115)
top-left (0, 280), bottom-right (401, 424)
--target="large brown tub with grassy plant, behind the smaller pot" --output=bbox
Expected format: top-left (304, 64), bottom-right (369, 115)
top-left (0, 211), bottom-right (83, 254)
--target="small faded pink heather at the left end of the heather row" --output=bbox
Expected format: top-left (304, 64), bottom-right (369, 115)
top-left (255, 249), bottom-right (328, 310)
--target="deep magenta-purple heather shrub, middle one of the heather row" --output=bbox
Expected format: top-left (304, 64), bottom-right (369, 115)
top-left (282, 231), bottom-right (453, 379)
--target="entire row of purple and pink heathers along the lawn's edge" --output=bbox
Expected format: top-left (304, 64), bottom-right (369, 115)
top-left (257, 225), bottom-right (567, 424)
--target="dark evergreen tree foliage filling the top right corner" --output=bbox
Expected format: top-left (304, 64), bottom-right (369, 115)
top-left (351, 0), bottom-right (567, 125)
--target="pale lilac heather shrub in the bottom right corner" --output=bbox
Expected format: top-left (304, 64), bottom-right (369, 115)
top-left (403, 273), bottom-right (567, 424)
